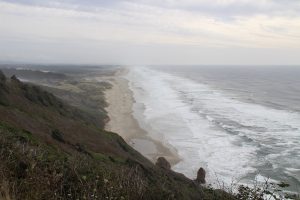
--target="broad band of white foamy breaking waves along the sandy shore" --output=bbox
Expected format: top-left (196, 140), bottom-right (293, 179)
top-left (127, 67), bottom-right (300, 189)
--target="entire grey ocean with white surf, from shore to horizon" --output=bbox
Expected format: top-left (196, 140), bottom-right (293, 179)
top-left (126, 66), bottom-right (300, 192)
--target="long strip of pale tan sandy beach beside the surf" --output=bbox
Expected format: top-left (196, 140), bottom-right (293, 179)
top-left (105, 69), bottom-right (180, 165)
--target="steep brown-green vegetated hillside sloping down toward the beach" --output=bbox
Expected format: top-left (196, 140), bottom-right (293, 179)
top-left (0, 72), bottom-right (232, 199)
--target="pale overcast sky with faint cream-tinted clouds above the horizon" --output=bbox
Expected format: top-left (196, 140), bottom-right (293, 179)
top-left (0, 0), bottom-right (300, 65)
